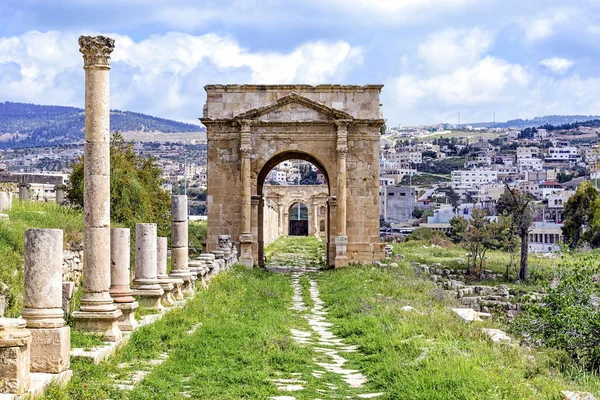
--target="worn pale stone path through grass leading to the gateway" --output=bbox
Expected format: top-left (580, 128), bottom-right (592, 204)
top-left (268, 267), bottom-right (383, 400)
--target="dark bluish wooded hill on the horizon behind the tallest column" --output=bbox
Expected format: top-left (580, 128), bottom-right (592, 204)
top-left (0, 102), bottom-right (205, 148)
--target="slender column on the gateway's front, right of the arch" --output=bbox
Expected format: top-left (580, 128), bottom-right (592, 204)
top-left (335, 121), bottom-right (348, 267)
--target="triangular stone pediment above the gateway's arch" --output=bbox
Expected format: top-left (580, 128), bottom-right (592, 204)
top-left (235, 93), bottom-right (352, 122)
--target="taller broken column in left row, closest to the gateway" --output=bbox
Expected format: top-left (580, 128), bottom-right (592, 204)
top-left (169, 195), bottom-right (194, 296)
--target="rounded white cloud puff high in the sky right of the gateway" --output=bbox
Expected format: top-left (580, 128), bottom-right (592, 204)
top-left (418, 27), bottom-right (494, 71)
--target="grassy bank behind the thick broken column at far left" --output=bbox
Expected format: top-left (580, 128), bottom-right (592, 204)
top-left (0, 201), bottom-right (83, 317)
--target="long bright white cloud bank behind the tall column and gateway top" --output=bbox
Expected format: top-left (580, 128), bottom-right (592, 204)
top-left (0, 32), bottom-right (362, 121)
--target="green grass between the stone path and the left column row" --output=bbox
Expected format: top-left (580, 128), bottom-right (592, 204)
top-left (43, 267), bottom-right (324, 399)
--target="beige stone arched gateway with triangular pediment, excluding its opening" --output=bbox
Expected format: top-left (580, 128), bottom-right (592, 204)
top-left (200, 85), bottom-right (384, 267)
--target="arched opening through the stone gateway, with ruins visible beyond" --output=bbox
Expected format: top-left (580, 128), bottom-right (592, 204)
top-left (255, 152), bottom-right (330, 266)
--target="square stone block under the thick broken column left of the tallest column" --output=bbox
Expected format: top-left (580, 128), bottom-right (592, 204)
top-left (29, 326), bottom-right (71, 374)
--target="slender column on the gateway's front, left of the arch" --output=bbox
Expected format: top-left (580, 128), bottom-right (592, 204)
top-left (240, 122), bottom-right (254, 267)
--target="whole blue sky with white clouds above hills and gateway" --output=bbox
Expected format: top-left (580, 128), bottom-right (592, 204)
top-left (0, 0), bottom-right (600, 126)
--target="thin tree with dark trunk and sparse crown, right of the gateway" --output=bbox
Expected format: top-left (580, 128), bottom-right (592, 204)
top-left (496, 185), bottom-right (534, 281)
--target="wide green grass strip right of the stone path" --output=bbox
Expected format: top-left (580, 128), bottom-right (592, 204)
top-left (318, 266), bottom-right (600, 400)
